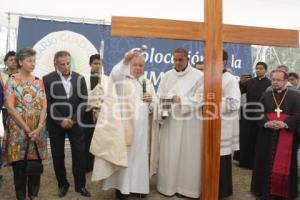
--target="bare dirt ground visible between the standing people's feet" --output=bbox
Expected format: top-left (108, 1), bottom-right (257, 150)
top-left (0, 145), bottom-right (296, 200)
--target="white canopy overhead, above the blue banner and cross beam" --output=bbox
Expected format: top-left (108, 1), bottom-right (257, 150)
top-left (0, 0), bottom-right (300, 29)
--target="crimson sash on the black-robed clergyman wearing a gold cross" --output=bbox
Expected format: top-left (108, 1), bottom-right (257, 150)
top-left (266, 113), bottom-right (294, 197)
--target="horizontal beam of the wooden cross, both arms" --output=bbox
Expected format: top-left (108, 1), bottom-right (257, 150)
top-left (111, 16), bottom-right (299, 48)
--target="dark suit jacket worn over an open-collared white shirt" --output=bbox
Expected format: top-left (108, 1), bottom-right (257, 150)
top-left (43, 71), bottom-right (88, 127)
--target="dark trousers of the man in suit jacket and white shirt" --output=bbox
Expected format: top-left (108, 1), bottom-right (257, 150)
top-left (48, 124), bottom-right (86, 189)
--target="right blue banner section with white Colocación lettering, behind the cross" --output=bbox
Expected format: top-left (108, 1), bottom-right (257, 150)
top-left (105, 34), bottom-right (252, 86)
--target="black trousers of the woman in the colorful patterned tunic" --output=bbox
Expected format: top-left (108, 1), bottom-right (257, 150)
top-left (12, 161), bottom-right (41, 200)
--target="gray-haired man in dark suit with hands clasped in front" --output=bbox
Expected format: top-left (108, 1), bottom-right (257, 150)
top-left (43, 51), bottom-right (91, 197)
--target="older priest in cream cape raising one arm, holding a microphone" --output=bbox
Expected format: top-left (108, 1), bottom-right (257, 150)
top-left (90, 52), bottom-right (155, 196)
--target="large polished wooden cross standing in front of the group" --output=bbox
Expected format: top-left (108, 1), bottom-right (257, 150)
top-left (111, 0), bottom-right (299, 200)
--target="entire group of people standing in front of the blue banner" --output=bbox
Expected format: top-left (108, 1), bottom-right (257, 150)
top-left (0, 48), bottom-right (300, 200)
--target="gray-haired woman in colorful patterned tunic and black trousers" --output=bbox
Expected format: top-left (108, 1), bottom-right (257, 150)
top-left (3, 48), bottom-right (47, 200)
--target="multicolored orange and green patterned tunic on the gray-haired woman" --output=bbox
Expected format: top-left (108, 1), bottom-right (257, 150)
top-left (3, 76), bottom-right (47, 163)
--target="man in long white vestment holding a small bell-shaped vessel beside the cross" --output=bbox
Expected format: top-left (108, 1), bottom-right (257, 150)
top-left (157, 48), bottom-right (203, 198)
